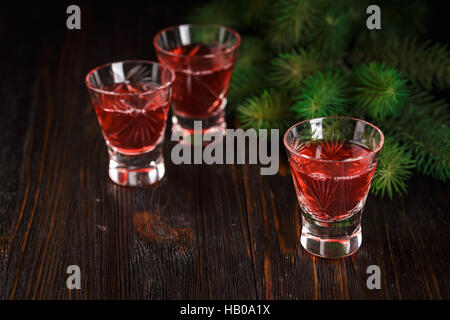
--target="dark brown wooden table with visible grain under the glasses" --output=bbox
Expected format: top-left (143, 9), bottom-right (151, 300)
top-left (0, 4), bottom-right (450, 299)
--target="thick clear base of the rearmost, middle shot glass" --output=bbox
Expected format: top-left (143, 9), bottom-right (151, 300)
top-left (172, 99), bottom-right (227, 145)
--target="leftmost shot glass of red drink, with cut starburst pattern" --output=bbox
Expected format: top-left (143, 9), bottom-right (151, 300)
top-left (85, 60), bottom-right (175, 186)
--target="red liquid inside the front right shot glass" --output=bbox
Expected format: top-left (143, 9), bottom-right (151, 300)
top-left (289, 141), bottom-right (376, 221)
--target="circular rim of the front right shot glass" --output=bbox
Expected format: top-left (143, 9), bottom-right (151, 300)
top-left (283, 116), bottom-right (384, 162)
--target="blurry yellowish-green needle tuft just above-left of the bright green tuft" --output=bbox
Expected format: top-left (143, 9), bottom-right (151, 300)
top-left (269, 49), bottom-right (324, 88)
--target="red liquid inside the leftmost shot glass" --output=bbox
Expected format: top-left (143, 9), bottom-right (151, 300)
top-left (94, 82), bottom-right (169, 154)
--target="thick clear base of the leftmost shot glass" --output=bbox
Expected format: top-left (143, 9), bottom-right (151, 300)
top-left (108, 144), bottom-right (165, 187)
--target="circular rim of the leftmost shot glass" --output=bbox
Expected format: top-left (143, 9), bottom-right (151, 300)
top-left (84, 60), bottom-right (175, 96)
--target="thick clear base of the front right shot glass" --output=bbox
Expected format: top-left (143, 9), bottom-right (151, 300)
top-left (300, 209), bottom-right (362, 258)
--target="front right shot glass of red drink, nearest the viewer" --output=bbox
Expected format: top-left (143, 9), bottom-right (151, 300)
top-left (284, 117), bottom-right (384, 258)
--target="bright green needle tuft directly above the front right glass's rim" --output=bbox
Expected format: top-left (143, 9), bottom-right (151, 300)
top-left (292, 71), bottom-right (347, 119)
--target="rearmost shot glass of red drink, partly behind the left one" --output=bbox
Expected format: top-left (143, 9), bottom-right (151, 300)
top-left (153, 24), bottom-right (241, 137)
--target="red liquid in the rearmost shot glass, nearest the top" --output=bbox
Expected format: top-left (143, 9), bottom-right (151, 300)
top-left (161, 44), bottom-right (235, 119)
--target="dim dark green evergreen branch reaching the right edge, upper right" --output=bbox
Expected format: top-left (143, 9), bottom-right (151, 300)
top-left (350, 35), bottom-right (450, 90)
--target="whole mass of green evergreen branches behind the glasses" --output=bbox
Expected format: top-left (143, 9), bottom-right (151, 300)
top-left (185, 0), bottom-right (450, 198)
